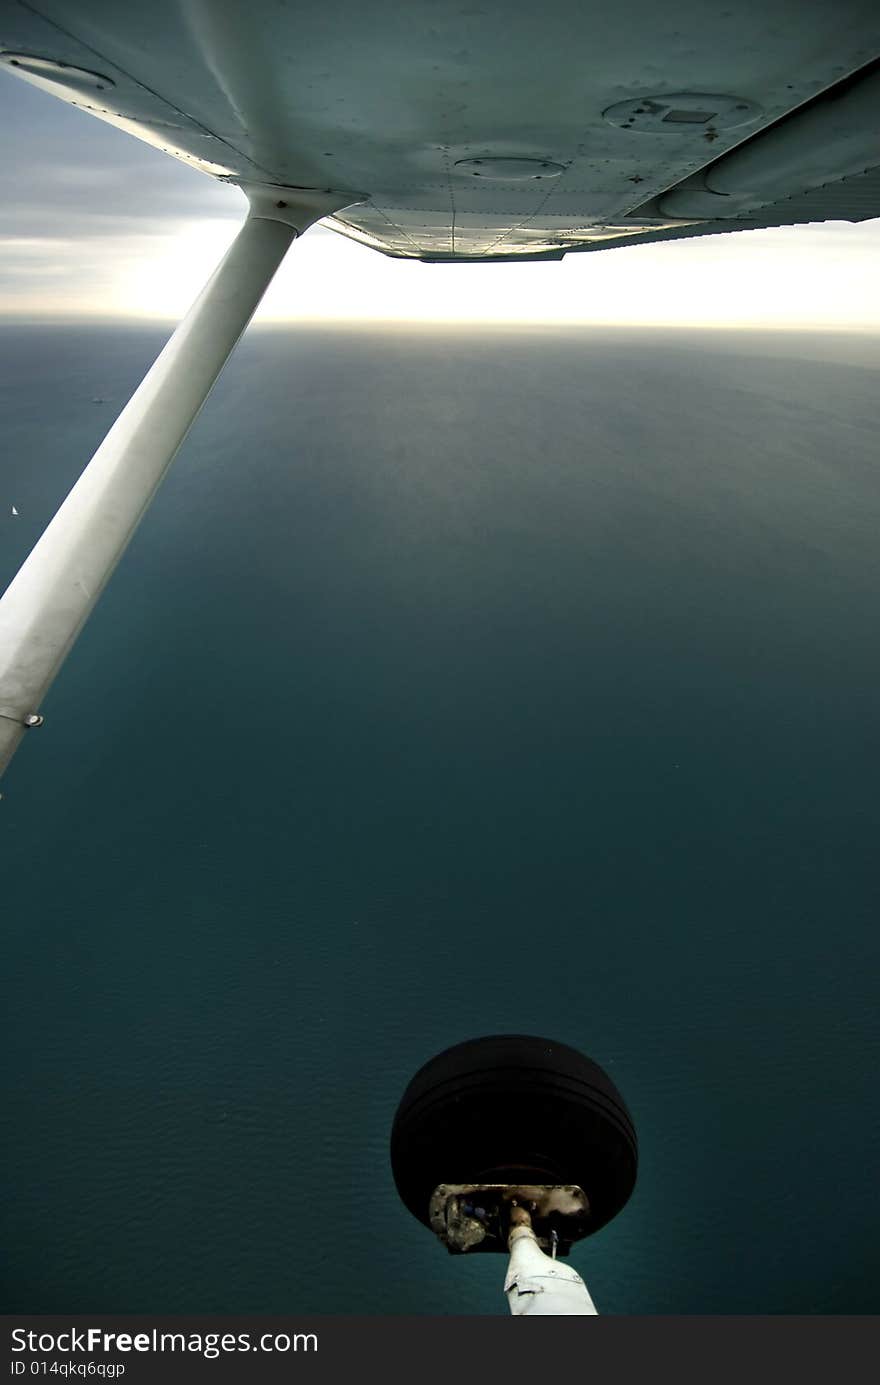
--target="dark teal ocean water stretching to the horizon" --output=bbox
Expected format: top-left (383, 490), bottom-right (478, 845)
top-left (0, 324), bottom-right (880, 1314)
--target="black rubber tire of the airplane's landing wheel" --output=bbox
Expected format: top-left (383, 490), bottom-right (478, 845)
top-left (391, 1035), bottom-right (637, 1234)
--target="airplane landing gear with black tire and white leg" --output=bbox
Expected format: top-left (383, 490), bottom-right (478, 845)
top-left (391, 1035), bottom-right (637, 1314)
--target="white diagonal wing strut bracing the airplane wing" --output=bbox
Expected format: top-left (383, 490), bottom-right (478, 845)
top-left (0, 186), bottom-right (355, 774)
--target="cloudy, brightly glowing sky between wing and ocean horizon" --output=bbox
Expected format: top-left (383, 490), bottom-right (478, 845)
top-left (0, 73), bottom-right (880, 331)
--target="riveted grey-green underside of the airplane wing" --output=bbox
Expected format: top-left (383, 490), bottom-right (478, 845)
top-left (0, 0), bottom-right (880, 260)
